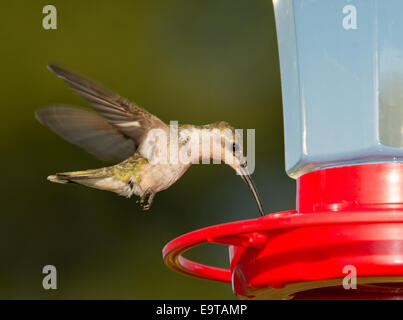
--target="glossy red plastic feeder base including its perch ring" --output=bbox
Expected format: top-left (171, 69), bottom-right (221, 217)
top-left (163, 162), bottom-right (403, 299)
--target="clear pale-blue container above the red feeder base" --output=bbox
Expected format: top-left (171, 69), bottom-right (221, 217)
top-left (273, 0), bottom-right (403, 178)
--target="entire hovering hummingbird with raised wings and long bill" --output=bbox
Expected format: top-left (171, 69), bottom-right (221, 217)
top-left (35, 64), bottom-right (264, 216)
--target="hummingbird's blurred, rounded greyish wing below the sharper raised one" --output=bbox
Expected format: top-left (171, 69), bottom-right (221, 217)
top-left (35, 106), bottom-right (136, 162)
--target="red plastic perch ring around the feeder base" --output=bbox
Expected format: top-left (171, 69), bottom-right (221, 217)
top-left (162, 211), bottom-right (403, 282)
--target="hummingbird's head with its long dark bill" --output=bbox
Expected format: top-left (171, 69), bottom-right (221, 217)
top-left (201, 121), bottom-right (264, 216)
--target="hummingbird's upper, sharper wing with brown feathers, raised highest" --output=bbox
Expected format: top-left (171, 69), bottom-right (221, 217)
top-left (48, 65), bottom-right (167, 146)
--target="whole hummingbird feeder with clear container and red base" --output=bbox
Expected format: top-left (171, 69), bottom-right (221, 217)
top-left (163, 0), bottom-right (403, 299)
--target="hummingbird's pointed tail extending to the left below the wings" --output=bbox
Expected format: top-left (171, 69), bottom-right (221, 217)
top-left (48, 168), bottom-right (137, 197)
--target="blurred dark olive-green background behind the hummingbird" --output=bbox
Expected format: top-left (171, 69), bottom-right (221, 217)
top-left (0, 0), bottom-right (295, 299)
